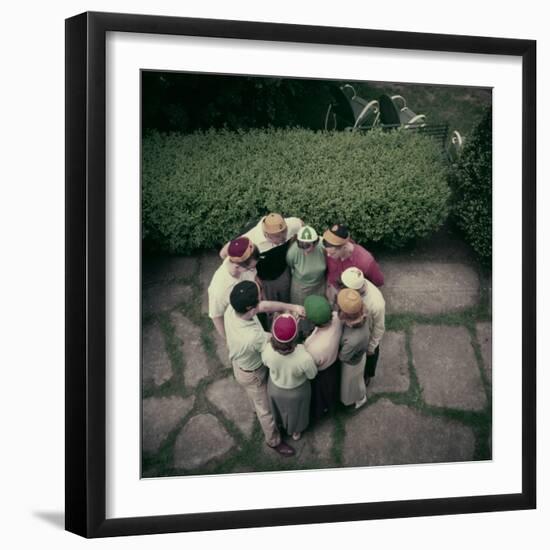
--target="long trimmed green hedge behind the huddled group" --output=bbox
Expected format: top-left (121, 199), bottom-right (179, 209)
top-left (142, 129), bottom-right (450, 253)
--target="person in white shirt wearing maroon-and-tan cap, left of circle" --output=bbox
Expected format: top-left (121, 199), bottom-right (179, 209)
top-left (208, 237), bottom-right (260, 340)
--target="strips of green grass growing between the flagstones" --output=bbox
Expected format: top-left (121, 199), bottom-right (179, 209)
top-left (142, 253), bottom-right (492, 477)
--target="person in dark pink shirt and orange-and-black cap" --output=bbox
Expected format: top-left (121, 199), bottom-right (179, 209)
top-left (323, 224), bottom-right (384, 304)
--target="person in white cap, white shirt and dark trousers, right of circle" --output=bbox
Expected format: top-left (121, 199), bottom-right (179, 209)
top-left (341, 267), bottom-right (386, 386)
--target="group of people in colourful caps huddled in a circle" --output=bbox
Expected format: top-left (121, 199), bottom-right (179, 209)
top-left (208, 213), bottom-right (385, 456)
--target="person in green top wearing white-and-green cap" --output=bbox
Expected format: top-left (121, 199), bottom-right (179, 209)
top-left (286, 225), bottom-right (327, 305)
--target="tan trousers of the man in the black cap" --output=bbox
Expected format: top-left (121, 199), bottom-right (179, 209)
top-left (233, 365), bottom-right (281, 447)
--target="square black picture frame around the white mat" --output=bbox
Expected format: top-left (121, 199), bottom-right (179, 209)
top-left (65, 12), bottom-right (536, 537)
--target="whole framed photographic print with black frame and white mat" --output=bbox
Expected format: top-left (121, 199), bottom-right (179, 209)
top-left (66, 13), bottom-right (536, 537)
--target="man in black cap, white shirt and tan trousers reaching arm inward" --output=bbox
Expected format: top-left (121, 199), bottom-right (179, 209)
top-left (224, 281), bottom-right (304, 456)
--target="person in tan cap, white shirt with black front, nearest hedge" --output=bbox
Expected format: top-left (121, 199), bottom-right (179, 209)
top-left (220, 213), bottom-right (303, 329)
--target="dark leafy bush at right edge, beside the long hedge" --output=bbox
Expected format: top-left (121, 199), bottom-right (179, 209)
top-left (451, 109), bottom-right (493, 263)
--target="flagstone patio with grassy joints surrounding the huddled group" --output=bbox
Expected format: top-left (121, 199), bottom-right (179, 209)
top-left (142, 237), bottom-right (492, 477)
